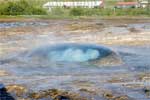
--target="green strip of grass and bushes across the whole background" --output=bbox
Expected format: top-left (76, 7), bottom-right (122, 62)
top-left (0, 0), bottom-right (150, 19)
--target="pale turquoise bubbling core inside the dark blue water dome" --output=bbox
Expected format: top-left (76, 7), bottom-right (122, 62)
top-left (48, 48), bottom-right (100, 62)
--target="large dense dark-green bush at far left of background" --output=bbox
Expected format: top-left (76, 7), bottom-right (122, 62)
top-left (0, 0), bottom-right (47, 15)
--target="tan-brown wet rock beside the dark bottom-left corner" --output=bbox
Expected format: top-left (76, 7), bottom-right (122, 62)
top-left (6, 85), bottom-right (27, 97)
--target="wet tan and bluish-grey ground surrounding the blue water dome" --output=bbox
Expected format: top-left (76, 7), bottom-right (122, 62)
top-left (0, 19), bottom-right (150, 100)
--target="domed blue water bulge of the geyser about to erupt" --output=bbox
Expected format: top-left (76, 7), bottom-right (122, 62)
top-left (28, 44), bottom-right (121, 64)
